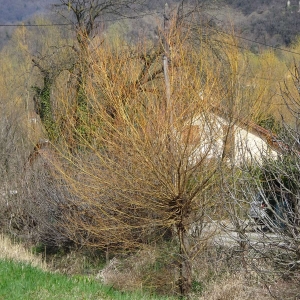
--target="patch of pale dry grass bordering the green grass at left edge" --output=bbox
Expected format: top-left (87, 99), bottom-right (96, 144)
top-left (0, 234), bottom-right (46, 270)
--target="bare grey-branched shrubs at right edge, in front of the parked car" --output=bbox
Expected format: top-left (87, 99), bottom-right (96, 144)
top-left (223, 66), bottom-right (300, 299)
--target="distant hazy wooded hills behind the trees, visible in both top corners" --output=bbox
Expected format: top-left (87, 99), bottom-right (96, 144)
top-left (0, 0), bottom-right (300, 51)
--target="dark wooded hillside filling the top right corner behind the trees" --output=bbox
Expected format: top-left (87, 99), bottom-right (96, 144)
top-left (219, 0), bottom-right (300, 46)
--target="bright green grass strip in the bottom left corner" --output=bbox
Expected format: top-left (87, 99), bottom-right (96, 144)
top-left (0, 260), bottom-right (174, 300)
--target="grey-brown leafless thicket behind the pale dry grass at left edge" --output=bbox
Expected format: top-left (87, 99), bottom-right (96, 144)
top-left (0, 102), bottom-right (71, 251)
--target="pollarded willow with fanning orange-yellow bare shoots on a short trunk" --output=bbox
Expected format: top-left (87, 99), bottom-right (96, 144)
top-left (46, 6), bottom-right (268, 295)
